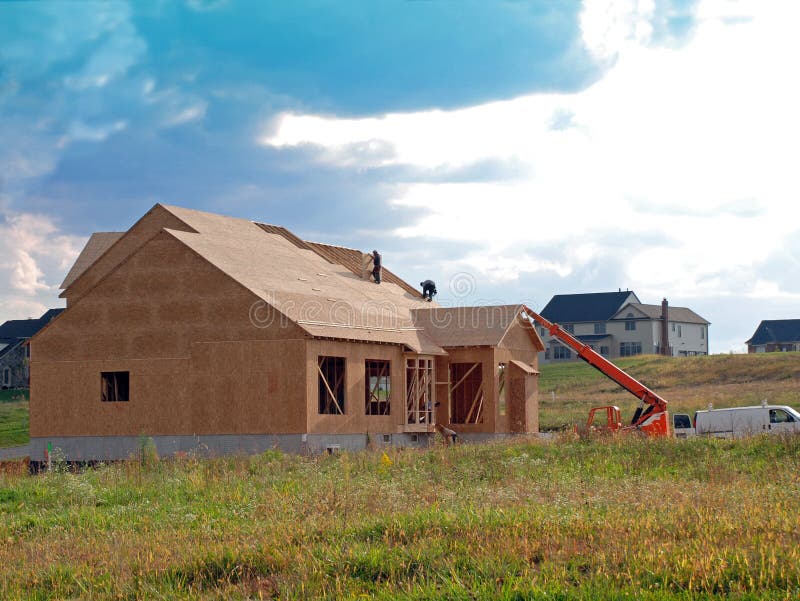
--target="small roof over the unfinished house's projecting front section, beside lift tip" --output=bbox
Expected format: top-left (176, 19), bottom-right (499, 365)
top-left (412, 305), bottom-right (544, 350)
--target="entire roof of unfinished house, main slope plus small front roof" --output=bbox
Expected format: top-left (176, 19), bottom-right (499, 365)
top-left (59, 204), bottom-right (541, 354)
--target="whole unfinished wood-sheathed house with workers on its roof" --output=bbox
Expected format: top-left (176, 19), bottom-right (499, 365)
top-left (30, 204), bottom-right (544, 461)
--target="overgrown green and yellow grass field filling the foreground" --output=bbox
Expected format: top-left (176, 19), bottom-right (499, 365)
top-left (0, 437), bottom-right (800, 600)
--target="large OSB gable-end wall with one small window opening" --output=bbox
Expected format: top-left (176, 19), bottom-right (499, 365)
top-left (30, 233), bottom-right (307, 437)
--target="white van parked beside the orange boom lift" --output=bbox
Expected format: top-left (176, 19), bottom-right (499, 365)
top-left (672, 404), bottom-right (800, 438)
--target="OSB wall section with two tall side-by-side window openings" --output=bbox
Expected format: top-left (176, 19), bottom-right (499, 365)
top-left (306, 340), bottom-right (406, 434)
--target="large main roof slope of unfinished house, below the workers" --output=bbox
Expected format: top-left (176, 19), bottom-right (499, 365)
top-left (155, 206), bottom-right (444, 354)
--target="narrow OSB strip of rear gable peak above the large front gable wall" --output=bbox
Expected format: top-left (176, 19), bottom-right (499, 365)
top-left (61, 205), bottom-right (193, 307)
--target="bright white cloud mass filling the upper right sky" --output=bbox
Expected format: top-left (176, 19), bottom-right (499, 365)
top-left (255, 0), bottom-right (800, 352)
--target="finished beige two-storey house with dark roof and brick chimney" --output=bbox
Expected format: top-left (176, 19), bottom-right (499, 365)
top-left (538, 290), bottom-right (710, 362)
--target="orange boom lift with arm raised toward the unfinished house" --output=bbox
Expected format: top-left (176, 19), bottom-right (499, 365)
top-left (523, 306), bottom-right (669, 436)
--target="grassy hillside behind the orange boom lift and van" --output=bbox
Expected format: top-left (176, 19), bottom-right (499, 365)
top-left (539, 353), bottom-right (800, 430)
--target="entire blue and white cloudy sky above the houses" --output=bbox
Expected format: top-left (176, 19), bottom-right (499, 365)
top-left (0, 0), bottom-right (800, 353)
